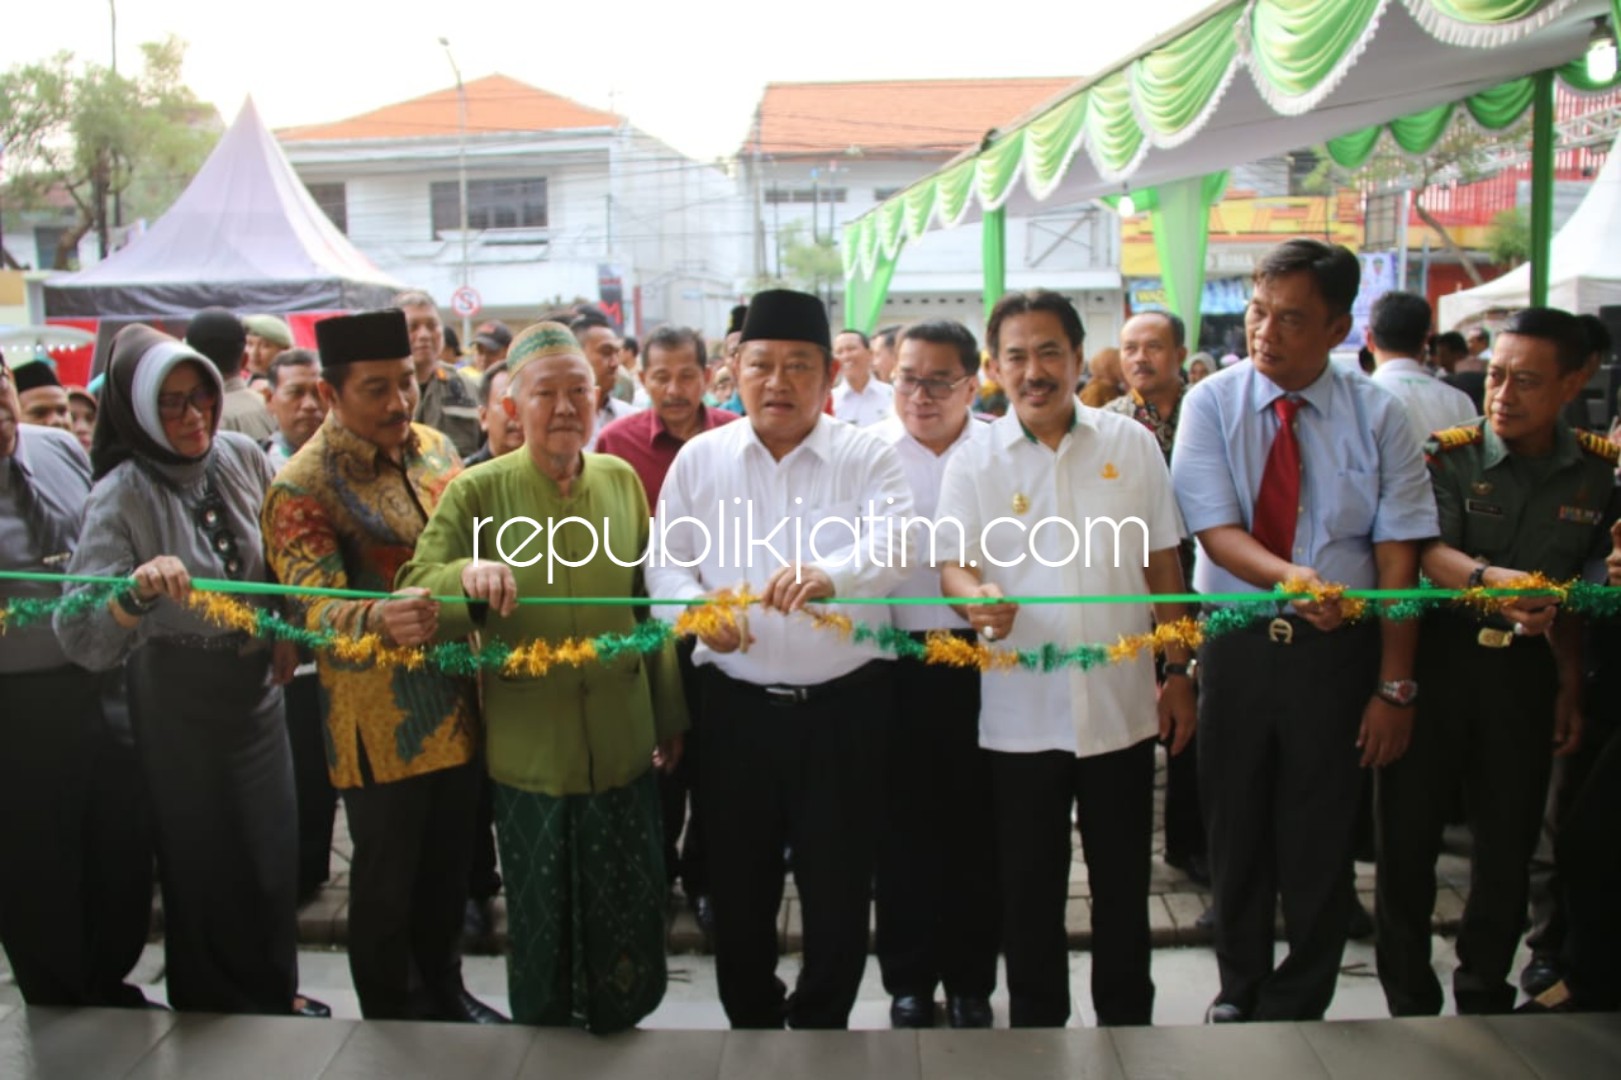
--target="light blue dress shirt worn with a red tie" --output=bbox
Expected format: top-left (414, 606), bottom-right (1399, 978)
top-left (1170, 360), bottom-right (1439, 594)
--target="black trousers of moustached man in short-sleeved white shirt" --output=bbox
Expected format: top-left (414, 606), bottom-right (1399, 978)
top-left (990, 739), bottom-right (1154, 1028)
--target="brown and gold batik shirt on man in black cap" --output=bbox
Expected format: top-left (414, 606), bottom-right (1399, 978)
top-left (263, 414), bottom-right (478, 788)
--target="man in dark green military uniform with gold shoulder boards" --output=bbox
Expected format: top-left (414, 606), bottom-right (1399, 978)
top-left (1376, 308), bottom-right (1621, 1017)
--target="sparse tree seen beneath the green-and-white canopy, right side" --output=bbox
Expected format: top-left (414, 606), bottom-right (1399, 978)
top-left (1303, 118), bottom-right (1530, 285)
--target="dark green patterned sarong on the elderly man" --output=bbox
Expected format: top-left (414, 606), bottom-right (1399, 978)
top-left (494, 770), bottom-right (666, 1035)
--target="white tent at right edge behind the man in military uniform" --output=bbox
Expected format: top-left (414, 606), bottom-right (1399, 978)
top-left (1436, 132), bottom-right (1621, 329)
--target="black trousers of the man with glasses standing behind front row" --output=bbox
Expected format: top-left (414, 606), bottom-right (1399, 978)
top-left (874, 638), bottom-right (999, 997)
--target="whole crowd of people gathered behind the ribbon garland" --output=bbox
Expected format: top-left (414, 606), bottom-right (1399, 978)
top-left (0, 231), bottom-right (1621, 1033)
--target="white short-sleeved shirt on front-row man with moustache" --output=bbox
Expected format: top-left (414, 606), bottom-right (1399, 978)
top-left (937, 401), bottom-right (1183, 757)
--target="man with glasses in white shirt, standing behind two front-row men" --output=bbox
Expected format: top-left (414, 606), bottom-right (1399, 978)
top-left (872, 321), bottom-right (999, 1028)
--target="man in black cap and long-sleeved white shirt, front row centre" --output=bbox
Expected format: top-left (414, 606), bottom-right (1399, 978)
top-left (647, 289), bottom-right (913, 1028)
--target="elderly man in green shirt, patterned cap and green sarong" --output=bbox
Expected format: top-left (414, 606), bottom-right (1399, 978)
top-left (397, 323), bottom-right (687, 1033)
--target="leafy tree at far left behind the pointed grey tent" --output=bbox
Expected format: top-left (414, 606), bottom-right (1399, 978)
top-left (0, 37), bottom-right (220, 269)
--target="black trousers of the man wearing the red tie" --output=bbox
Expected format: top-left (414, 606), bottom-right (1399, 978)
top-left (1200, 618), bottom-right (1379, 1020)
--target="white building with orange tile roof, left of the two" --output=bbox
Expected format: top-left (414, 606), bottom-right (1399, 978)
top-left (277, 75), bottom-right (746, 332)
